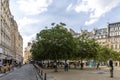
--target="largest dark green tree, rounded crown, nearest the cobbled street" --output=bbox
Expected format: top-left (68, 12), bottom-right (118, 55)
top-left (31, 23), bottom-right (76, 71)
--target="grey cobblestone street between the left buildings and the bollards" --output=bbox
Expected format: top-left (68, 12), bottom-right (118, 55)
top-left (0, 64), bottom-right (37, 80)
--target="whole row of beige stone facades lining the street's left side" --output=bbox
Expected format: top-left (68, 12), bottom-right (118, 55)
top-left (0, 0), bottom-right (23, 62)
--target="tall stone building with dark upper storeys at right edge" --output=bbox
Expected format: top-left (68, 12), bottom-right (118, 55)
top-left (108, 22), bottom-right (120, 51)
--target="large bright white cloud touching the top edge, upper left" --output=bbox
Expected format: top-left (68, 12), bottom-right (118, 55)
top-left (17, 0), bottom-right (52, 15)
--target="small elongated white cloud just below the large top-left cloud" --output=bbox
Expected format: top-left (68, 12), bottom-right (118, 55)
top-left (18, 17), bottom-right (39, 27)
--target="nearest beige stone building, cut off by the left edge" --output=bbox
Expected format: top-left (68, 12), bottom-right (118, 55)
top-left (0, 0), bottom-right (13, 57)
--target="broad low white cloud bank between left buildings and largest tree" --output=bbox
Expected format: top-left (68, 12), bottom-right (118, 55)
top-left (18, 16), bottom-right (49, 49)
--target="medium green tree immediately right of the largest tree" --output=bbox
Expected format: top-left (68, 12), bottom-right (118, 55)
top-left (76, 34), bottom-right (99, 69)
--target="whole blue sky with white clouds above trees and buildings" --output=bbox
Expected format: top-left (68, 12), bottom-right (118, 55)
top-left (9, 0), bottom-right (120, 48)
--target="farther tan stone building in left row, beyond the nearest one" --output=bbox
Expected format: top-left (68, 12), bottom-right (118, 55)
top-left (12, 20), bottom-right (23, 61)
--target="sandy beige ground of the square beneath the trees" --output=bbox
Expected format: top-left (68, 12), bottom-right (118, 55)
top-left (44, 69), bottom-right (120, 80)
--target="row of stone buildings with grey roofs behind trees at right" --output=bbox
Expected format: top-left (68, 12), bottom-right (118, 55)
top-left (80, 22), bottom-right (120, 52)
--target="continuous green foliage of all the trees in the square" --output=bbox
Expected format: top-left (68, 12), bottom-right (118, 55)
top-left (31, 23), bottom-right (120, 65)
